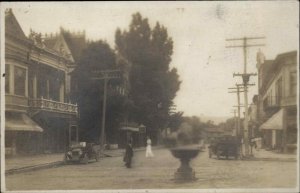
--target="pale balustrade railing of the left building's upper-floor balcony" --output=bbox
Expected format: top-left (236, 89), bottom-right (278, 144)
top-left (29, 98), bottom-right (78, 114)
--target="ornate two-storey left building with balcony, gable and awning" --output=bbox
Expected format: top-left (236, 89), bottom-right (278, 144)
top-left (5, 9), bottom-right (78, 155)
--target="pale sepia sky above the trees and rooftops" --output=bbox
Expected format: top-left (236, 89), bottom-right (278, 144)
top-left (1, 1), bottom-right (299, 117)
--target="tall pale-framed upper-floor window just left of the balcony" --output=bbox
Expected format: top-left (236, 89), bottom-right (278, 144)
top-left (14, 66), bottom-right (26, 96)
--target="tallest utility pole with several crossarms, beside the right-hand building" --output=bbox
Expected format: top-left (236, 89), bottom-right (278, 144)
top-left (226, 37), bottom-right (265, 157)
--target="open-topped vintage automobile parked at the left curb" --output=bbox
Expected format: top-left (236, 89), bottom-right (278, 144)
top-left (64, 142), bottom-right (101, 164)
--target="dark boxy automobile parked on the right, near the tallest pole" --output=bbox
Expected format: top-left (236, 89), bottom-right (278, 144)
top-left (209, 136), bottom-right (240, 159)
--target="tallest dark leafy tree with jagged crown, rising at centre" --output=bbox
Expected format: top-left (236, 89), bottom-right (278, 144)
top-left (115, 13), bottom-right (180, 142)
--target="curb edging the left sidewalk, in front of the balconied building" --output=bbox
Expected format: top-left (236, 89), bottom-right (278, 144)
top-left (5, 161), bottom-right (64, 175)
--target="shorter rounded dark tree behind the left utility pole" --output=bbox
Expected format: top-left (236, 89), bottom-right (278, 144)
top-left (73, 41), bottom-right (125, 143)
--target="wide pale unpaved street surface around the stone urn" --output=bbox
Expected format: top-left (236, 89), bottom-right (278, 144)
top-left (6, 149), bottom-right (297, 190)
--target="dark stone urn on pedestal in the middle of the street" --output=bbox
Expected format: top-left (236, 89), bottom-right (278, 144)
top-left (170, 147), bottom-right (200, 182)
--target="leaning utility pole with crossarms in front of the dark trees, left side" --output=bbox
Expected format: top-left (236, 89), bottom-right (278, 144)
top-left (92, 70), bottom-right (121, 150)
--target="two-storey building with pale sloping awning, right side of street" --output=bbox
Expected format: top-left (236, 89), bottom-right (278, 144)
top-left (257, 51), bottom-right (298, 152)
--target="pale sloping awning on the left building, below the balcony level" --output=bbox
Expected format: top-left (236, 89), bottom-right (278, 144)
top-left (5, 112), bottom-right (43, 132)
